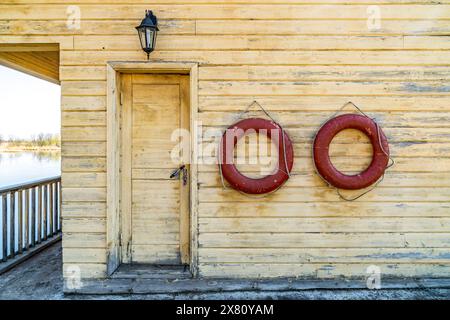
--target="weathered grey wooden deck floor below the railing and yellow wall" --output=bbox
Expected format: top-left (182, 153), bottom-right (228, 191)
top-left (0, 242), bottom-right (450, 300)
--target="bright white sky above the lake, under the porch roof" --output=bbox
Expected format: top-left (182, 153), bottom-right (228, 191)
top-left (0, 66), bottom-right (61, 139)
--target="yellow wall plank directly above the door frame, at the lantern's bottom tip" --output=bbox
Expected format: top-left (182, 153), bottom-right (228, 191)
top-left (61, 50), bottom-right (450, 66)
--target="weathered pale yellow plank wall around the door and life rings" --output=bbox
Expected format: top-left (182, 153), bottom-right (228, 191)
top-left (0, 0), bottom-right (450, 277)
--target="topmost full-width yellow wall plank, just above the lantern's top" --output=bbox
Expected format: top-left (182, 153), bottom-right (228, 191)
top-left (0, 4), bottom-right (450, 20)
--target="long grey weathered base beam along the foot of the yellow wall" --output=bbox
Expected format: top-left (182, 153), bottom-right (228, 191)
top-left (64, 278), bottom-right (450, 294)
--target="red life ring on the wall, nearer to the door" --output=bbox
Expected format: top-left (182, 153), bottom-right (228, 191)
top-left (219, 118), bottom-right (294, 194)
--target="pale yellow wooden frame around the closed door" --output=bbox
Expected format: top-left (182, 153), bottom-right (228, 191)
top-left (106, 61), bottom-right (198, 277)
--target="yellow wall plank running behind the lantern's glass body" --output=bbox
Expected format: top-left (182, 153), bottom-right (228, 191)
top-left (74, 34), bottom-right (450, 51)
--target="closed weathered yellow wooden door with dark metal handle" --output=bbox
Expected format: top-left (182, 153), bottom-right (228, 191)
top-left (121, 74), bottom-right (190, 265)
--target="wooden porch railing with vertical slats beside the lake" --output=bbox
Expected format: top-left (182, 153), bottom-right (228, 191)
top-left (0, 176), bottom-right (61, 269)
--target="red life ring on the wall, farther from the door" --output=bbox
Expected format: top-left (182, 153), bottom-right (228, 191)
top-left (313, 114), bottom-right (389, 190)
